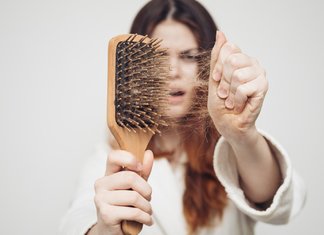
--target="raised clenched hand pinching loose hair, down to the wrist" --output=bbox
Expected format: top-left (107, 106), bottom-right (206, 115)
top-left (208, 31), bottom-right (268, 141)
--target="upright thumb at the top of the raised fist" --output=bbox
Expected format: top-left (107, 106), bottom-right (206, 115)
top-left (209, 31), bottom-right (227, 85)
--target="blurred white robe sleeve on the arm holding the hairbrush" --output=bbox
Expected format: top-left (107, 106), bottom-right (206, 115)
top-left (59, 143), bottom-right (109, 235)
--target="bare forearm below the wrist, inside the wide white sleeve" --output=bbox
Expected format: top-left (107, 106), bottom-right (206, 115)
top-left (230, 130), bottom-right (281, 203)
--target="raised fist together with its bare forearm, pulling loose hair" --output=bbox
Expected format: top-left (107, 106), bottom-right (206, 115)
top-left (208, 32), bottom-right (281, 204)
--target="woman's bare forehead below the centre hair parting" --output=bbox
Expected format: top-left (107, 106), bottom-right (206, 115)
top-left (152, 19), bottom-right (198, 51)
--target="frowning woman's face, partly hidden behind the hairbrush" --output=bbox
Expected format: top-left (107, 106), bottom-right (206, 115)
top-left (152, 19), bottom-right (198, 118)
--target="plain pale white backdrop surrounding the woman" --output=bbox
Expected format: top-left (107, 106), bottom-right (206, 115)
top-left (0, 0), bottom-right (324, 235)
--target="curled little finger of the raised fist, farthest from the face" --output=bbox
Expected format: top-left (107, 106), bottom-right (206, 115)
top-left (234, 75), bottom-right (268, 113)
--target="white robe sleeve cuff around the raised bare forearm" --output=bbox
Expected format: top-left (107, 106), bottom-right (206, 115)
top-left (214, 131), bottom-right (306, 224)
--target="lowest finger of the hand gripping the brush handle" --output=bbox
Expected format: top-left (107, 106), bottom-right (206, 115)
top-left (100, 205), bottom-right (153, 226)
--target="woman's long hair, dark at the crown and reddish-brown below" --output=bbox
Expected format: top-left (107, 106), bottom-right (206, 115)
top-left (130, 0), bottom-right (227, 234)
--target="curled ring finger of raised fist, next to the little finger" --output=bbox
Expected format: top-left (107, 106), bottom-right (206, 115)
top-left (225, 66), bottom-right (264, 109)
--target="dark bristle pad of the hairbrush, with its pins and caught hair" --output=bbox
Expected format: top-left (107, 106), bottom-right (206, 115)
top-left (115, 34), bottom-right (168, 134)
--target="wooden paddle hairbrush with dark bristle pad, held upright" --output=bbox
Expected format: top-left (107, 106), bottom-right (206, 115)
top-left (107, 34), bottom-right (168, 235)
